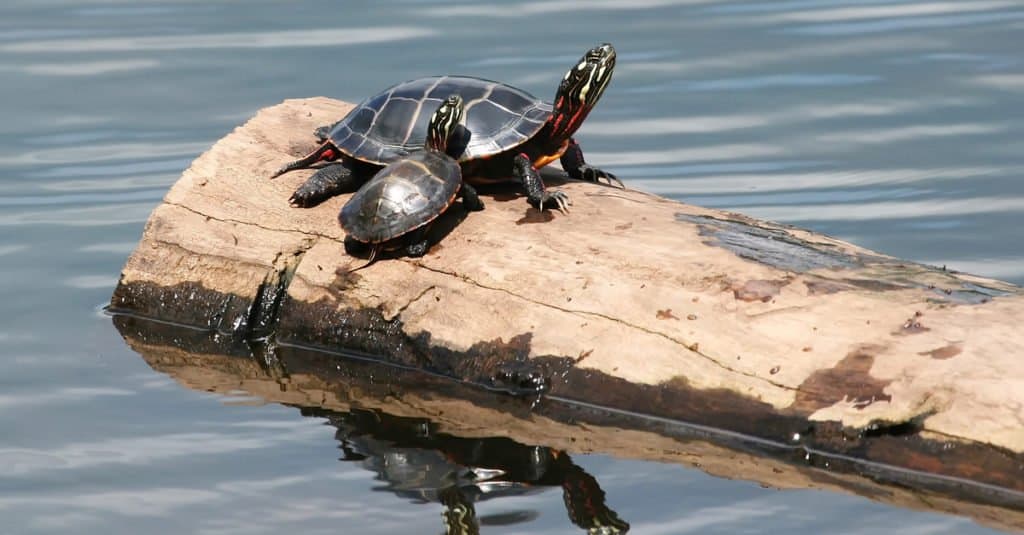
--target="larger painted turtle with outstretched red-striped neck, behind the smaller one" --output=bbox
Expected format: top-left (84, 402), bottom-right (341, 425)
top-left (273, 43), bottom-right (622, 209)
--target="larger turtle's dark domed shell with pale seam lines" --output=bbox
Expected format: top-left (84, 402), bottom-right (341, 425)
top-left (328, 76), bottom-right (552, 165)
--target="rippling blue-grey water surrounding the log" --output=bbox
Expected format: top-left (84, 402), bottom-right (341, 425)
top-left (0, 0), bottom-right (1024, 534)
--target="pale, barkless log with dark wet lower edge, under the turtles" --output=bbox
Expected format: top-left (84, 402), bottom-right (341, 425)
top-left (111, 98), bottom-right (1024, 477)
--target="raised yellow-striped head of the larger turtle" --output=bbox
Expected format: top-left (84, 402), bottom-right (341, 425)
top-left (551, 43), bottom-right (615, 138)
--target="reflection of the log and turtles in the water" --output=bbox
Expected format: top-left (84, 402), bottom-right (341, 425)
top-left (113, 315), bottom-right (1024, 534)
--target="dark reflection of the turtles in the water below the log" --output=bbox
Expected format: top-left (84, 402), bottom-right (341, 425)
top-left (302, 409), bottom-right (630, 535)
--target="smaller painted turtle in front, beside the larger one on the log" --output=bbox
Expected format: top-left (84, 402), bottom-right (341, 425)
top-left (338, 94), bottom-right (483, 270)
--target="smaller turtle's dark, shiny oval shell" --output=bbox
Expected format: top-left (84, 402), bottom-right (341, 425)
top-left (338, 150), bottom-right (462, 244)
